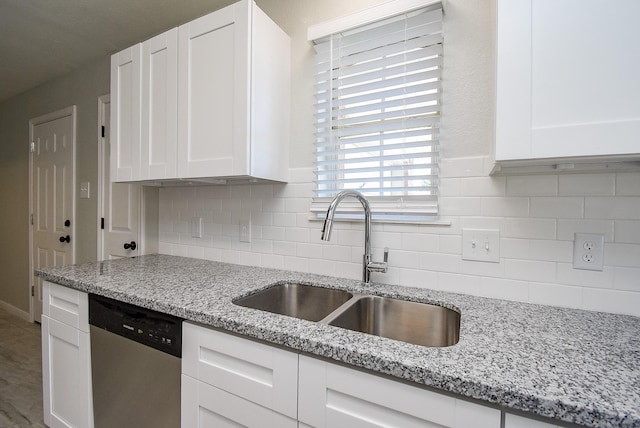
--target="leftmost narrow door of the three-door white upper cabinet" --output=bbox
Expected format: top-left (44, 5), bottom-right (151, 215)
top-left (110, 44), bottom-right (142, 182)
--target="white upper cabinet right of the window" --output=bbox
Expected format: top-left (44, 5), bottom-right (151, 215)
top-left (495, 0), bottom-right (640, 172)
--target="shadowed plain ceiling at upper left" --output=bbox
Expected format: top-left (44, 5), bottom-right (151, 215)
top-left (0, 0), bottom-right (235, 103)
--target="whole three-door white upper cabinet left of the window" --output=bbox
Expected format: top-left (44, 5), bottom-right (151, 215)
top-left (111, 0), bottom-right (291, 182)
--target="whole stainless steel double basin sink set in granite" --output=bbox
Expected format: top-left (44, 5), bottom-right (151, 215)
top-left (233, 283), bottom-right (460, 347)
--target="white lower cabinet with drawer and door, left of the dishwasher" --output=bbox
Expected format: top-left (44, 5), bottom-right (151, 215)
top-left (42, 282), bottom-right (93, 428)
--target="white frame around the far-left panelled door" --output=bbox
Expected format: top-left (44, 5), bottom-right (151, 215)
top-left (27, 105), bottom-right (77, 322)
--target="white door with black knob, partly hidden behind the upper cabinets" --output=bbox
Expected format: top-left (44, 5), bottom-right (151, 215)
top-left (98, 97), bottom-right (141, 259)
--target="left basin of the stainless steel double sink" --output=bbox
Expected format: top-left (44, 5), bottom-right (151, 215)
top-left (234, 283), bottom-right (353, 321)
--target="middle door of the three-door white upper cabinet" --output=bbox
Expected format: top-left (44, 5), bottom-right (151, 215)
top-left (140, 28), bottom-right (178, 180)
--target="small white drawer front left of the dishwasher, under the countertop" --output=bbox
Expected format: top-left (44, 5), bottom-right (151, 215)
top-left (42, 281), bottom-right (89, 333)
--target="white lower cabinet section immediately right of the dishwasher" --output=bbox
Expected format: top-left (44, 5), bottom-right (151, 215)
top-left (181, 322), bottom-right (298, 428)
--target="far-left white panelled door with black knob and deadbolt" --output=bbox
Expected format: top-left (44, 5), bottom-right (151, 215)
top-left (29, 106), bottom-right (76, 322)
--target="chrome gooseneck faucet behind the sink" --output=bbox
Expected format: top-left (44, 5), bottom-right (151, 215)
top-left (321, 190), bottom-right (389, 284)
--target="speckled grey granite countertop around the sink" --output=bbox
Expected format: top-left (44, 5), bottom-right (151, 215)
top-left (37, 255), bottom-right (640, 427)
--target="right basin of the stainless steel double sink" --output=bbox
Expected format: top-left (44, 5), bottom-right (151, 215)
top-left (328, 296), bottom-right (460, 346)
